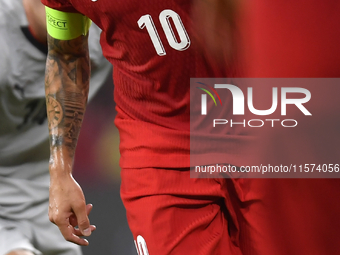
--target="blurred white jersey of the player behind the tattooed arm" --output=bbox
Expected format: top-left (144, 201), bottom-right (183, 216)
top-left (0, 0), bottom-right (112, 219)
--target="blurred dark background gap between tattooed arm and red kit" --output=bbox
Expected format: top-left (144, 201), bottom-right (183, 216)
top-left (74, 75), bottom-right (137, 255)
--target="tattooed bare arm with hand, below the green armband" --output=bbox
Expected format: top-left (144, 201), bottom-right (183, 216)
top-left (45, 32), bottom-right (95, 245)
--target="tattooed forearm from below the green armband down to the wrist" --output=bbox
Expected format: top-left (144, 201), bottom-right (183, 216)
top-left (45, 33), bottom-right (90, 162)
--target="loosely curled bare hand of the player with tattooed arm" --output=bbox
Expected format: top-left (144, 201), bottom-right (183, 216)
top-left (48, 174), bottom-right (96, 246)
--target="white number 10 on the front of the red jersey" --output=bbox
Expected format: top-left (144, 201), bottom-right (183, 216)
top-left (138, 10), bottom-right (190, 56)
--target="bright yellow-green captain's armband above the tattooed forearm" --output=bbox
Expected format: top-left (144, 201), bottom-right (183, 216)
top-left (45, 7), bottom-right (91, 40)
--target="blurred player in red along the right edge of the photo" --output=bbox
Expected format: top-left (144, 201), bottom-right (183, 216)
top-left (242, 0), bottom-right (340, 255)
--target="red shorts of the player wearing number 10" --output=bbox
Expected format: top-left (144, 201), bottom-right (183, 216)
top-left (121, 168), bottom-right (257, 255)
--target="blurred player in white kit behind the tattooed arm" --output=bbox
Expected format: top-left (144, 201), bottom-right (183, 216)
top-left (0, 0), bottom-right (112, 255)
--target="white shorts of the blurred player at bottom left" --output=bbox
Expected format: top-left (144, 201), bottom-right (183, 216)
top-left (0, 205), bottom-right (82, 255)
